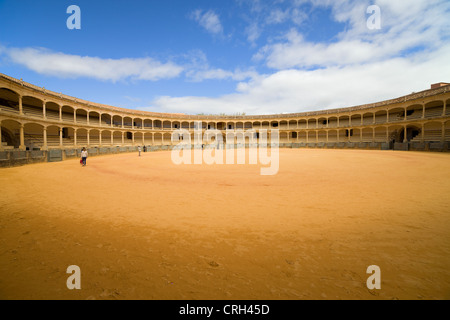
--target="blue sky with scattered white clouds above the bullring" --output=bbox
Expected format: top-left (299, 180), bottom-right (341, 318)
top-left (0, 0), bottom-right (450, 115)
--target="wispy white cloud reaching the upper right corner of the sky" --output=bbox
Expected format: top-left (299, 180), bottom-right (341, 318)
top-left (254, 0), bottom-right (450, 69)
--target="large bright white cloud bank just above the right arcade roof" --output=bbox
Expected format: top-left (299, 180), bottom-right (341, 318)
top-left (144, 45), bottom-right (450, 114)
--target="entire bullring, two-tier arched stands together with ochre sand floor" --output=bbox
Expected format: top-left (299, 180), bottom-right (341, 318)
top-left (0, 75), bottom-right (450, 300)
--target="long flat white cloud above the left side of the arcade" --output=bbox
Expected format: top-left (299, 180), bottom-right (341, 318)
top-left (4, 48), bottom-right (183, 81)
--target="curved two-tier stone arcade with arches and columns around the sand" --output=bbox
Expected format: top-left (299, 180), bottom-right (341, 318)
top-left (0, 74), bottom-right (450, 155)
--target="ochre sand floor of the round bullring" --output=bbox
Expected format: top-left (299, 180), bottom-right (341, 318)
top-left (0, 149), bottom-right (450, 299)
